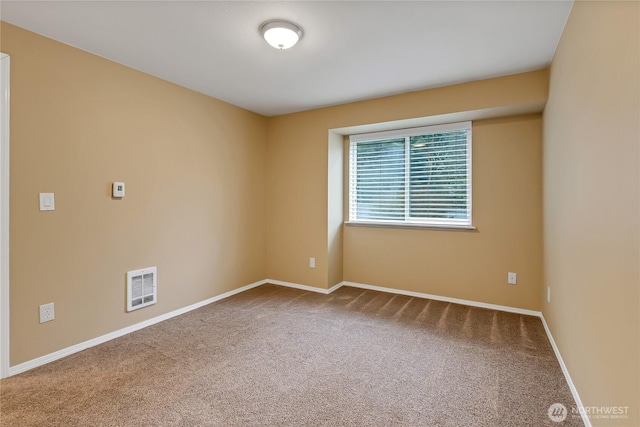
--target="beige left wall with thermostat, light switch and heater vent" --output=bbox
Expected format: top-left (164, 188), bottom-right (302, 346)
top-left (1, 24), bottom-right (267, 365)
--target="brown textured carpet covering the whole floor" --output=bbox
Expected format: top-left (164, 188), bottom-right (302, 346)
top-left (0, 285), bottom-right (582, 427)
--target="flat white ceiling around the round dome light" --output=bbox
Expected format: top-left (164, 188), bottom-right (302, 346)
top-left (0, 0), bottom-right (573, 116)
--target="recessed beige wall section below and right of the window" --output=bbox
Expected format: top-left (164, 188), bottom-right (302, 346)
top-left (344, 114), bottom-right (542, 310)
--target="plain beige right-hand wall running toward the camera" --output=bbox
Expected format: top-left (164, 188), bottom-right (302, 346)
top-left (540, 2), bottom-right (640, 426)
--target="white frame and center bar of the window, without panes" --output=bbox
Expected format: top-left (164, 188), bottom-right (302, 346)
top-left (346, 121), bottom-right (475, 230)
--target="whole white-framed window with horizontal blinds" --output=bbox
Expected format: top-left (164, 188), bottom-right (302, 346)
top-left (349, 122), bottom-right (473, 228)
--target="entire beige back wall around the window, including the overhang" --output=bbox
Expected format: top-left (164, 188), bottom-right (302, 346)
top-left (266, 70), bottom-right (548, 309)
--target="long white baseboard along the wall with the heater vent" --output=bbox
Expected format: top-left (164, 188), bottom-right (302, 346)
top-left (7, 280), bottom-right (267, 377)
